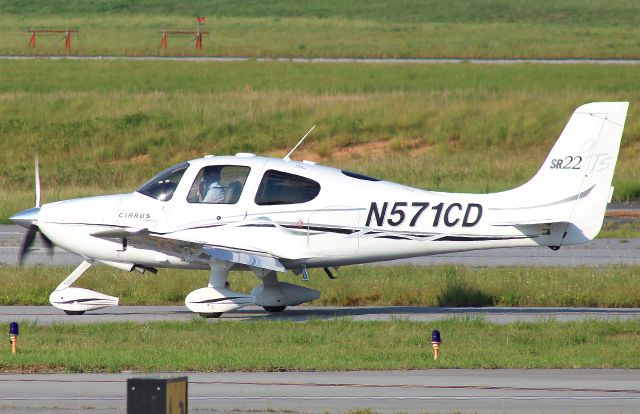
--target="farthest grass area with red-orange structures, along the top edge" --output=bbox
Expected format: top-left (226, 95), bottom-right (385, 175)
top-left (0, 0), bottom-right (640, 58)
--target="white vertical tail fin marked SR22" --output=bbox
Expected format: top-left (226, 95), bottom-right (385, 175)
top-left (503, 102), bottom-right (629, 245)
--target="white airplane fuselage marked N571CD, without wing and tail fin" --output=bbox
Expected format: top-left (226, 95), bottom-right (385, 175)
top-left (27, 154), bottom-right (554, 269)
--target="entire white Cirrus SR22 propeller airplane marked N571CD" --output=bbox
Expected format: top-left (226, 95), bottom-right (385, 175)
top-left (11, 102), bottom-right (628, 317)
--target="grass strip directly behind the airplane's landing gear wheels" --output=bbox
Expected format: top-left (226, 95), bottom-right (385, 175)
top-left (5, 265), bottom-right (640, 308)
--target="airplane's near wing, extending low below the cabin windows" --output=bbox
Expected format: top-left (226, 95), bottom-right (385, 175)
top-left (91, 228), bottom-right (287, 272)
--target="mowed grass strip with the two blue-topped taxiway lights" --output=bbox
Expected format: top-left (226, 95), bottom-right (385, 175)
top-left (0, 318), bottom-right (640, 372)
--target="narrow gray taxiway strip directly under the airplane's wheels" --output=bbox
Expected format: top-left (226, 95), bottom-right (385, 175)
top-left (0, 306), bottom-right (640, 324)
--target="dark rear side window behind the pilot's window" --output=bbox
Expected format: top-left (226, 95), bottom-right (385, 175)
top-left (255, 170), bottom-right (320, 206)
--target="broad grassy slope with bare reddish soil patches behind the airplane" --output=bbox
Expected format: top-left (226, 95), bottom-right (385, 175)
top-left (0, 61), bottom-right (640, 225)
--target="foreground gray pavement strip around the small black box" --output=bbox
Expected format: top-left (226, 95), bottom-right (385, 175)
top-left (0, 369), bottom-right (640, 414)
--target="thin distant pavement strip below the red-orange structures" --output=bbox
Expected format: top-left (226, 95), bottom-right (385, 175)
top-left (0, 55), bottom-right (640, 65)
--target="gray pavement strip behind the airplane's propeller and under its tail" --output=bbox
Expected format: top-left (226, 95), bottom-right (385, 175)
top-left (0, 225), bottom-right (640, 267)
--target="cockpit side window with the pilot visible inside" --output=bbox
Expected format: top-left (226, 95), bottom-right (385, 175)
top-left (187, 165), bottom-right (251, 204)
